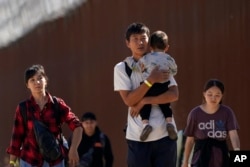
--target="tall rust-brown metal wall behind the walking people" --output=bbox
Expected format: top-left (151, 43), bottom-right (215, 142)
top-left (0, 0), bottom-right (250, 167)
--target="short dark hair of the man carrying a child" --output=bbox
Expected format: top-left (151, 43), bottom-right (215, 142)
top-left (125, 23), bottom-right (150, 41)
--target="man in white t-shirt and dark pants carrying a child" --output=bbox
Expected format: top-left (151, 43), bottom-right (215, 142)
top-left (114, 23), bottom-right (178, 167)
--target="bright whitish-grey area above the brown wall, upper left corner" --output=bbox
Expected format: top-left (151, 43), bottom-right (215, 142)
top-left (0, 0), bottom-right (87, 48)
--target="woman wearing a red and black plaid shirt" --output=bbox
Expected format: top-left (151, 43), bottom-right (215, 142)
top-left (6, 64), bottom-right (82, 167)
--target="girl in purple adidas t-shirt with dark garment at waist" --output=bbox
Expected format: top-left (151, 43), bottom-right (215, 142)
top-left (182, 79), bottom-right (240, 167)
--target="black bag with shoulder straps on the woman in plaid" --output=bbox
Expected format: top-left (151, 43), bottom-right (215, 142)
top-left (19, 96), bottom-right (63, 162)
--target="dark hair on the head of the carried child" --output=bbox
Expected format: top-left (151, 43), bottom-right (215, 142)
top-left (149, 31), bottom-right (168, 50)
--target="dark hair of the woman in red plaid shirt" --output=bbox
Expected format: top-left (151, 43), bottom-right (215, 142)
top-left (24, 64), bottom-right (48, 84)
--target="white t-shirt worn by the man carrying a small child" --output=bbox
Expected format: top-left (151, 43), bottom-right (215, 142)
top-left (114, 57), bottom-right (177, 142)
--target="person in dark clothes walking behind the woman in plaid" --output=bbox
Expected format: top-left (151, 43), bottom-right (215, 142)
top-left (68, 112), bottom-right (114, 167)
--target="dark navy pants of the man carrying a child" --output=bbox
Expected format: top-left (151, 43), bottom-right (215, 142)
top-left (127, 137), bottom-right (177, 167)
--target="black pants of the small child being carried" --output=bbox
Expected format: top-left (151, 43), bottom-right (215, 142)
top-left (140, 81), bottom-right (172, 120)
